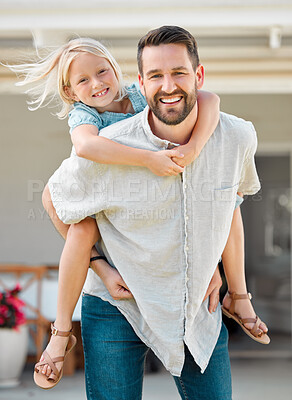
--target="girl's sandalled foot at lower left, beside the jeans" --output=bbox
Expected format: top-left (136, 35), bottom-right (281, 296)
top-left (34, 325), bottom-right (76, 389)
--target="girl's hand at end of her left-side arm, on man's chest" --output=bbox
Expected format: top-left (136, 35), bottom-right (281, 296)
top-left (146, 149), bottom-right (184, 176)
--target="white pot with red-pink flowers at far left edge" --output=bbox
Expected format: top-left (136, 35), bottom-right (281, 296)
top-left (0, 285), bottom-right (28, 388)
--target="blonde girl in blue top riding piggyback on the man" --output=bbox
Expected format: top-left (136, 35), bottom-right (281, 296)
top-left (11, 38), bottom-right (269, 389)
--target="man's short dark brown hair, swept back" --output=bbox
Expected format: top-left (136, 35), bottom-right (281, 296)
top-left (137, 25), bottom-right (200, 76)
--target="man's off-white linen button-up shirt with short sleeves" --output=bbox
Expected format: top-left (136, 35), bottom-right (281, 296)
top-left (49, 107), bottom-right (260, 376)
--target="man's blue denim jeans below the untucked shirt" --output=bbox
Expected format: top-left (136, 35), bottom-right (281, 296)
top-left (81, 294), bottom-right (231, 400)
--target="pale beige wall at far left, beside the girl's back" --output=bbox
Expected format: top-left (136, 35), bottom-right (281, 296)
top-left (0, 95), bottom-right (71, 264)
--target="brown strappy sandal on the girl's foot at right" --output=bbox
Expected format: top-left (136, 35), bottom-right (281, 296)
top-left (221, 292), bottom-right (270, 344)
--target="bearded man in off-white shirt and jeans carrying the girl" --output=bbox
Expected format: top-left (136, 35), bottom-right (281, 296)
top-left (78, 26), bottom-right (259, 400)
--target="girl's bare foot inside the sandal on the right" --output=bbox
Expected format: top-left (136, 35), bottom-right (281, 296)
top-left (222, 292), bottom-right (268, 333)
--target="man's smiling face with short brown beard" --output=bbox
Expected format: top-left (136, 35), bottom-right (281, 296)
top-left (139, 44), bottom-right (202, 125)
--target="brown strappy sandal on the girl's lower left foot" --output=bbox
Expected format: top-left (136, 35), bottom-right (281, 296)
top-left (33, 324), bottom-right (77, 389)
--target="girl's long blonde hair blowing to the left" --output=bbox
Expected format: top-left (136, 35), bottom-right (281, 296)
top-left (8, 38), bottom-right (127, 119)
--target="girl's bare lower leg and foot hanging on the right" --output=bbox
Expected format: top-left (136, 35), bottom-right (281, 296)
top-left (222, 207), bottom-right (267, 332)
